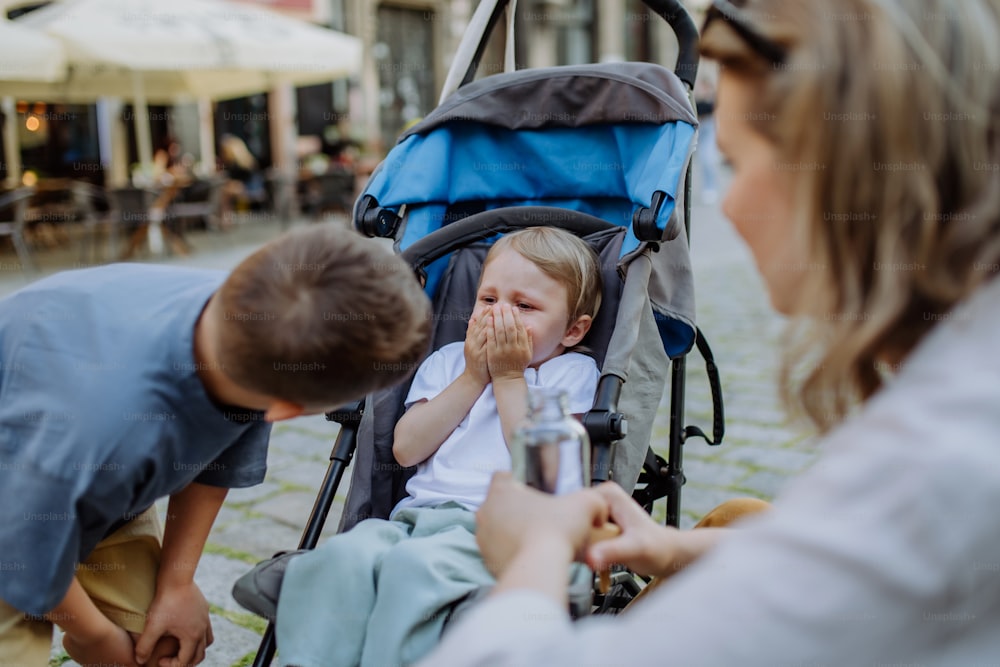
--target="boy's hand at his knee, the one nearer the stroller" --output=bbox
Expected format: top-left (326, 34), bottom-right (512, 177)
top-left (135, 582), bottom-right (215, 667)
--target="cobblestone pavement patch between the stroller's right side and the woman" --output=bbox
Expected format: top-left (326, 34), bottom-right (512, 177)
top-left (653, 193), bottom-right (817, 528)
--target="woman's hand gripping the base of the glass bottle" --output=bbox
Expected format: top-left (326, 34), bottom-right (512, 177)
top-left (476, 472), bottom-right (608, 578)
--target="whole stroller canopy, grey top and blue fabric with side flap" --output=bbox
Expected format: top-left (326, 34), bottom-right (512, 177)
top-left (364, 63), bottom-right (697, 357)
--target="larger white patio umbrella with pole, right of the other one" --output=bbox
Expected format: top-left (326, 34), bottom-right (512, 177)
top-left (0, 0), bottom-right (361, 175)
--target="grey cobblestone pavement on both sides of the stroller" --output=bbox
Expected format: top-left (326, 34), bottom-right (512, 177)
top-left (0, 196), bottom-right (816, 667)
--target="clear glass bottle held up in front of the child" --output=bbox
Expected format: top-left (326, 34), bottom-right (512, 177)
top-left (511, 387), bottom-right (590, 494)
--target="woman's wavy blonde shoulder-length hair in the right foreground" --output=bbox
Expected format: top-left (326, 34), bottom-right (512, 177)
top-left (701, 0), bottom-right (1000, 431)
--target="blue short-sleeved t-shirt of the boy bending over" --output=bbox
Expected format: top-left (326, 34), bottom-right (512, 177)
top-left (0, 264), bottom-right (270, 614)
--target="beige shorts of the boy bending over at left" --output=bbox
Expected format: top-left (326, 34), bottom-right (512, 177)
top-left (0, 507), bottom-right (162, 667)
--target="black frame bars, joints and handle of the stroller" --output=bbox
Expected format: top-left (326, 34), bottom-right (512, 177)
top-left (253, 0), bottom-right (724, 667)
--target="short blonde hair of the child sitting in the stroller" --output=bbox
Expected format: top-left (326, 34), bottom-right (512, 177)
top-left (483, 227), bottom-right (601, 322)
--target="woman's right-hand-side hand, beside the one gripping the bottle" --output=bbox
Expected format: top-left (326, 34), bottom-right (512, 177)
top-left (585, 482), bottom-right (686, 576)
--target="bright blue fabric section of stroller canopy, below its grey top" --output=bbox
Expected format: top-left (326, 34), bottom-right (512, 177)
top-left (368, 122), bottom-right (694, 254)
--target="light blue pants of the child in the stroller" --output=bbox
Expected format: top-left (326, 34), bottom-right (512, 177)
top-left (276, 502), bottom-right (494, 667)
